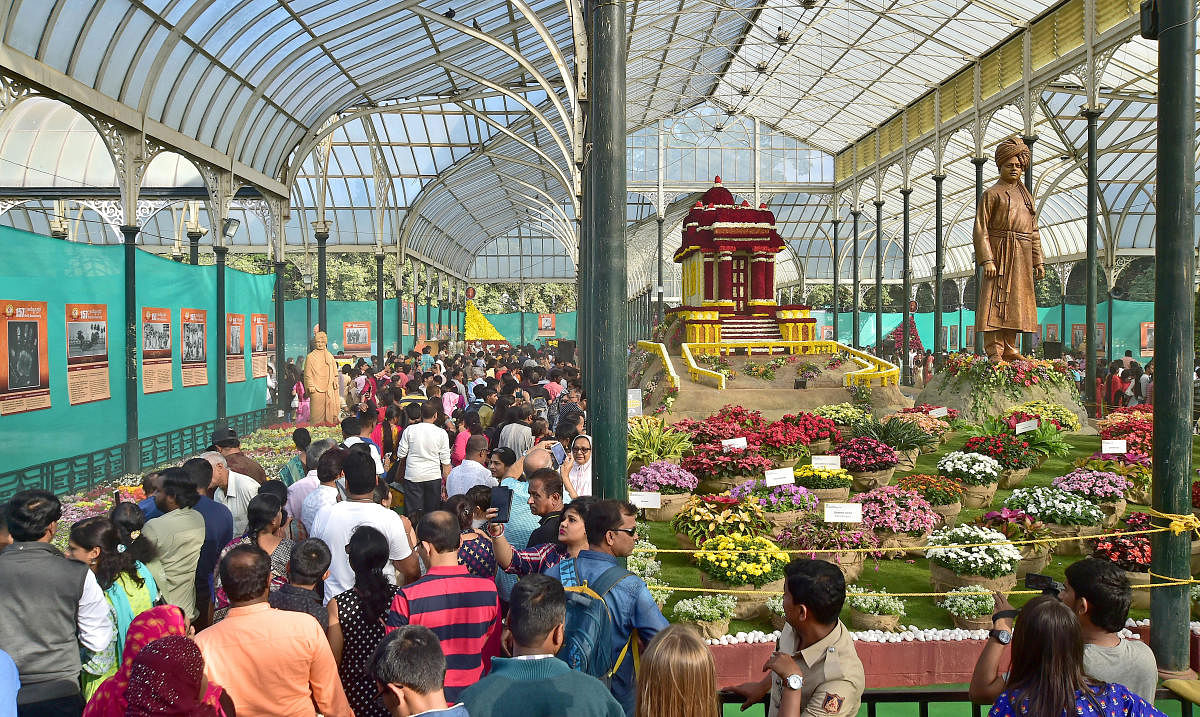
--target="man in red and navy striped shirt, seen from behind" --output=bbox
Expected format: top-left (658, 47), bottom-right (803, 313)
top-left (386, 511), bottom-right (500, 703)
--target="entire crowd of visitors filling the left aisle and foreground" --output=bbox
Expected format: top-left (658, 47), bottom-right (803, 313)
top-left (0, 351), bottom-right (1180, 717)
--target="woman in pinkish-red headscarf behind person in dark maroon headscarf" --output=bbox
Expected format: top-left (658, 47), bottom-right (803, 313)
top-left (83, 605), bottom-right (233, 717)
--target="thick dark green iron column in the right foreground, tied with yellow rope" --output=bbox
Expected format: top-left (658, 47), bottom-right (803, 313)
top-left (1150, 0), bottom-right (1196, 676)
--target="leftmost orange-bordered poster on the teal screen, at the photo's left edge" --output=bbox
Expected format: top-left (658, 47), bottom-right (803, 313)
top-left (0, 301), bottom-right (50, 416)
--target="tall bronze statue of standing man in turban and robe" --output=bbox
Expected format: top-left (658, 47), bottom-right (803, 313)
top-left (974, 137), bottom-right (1046, 361)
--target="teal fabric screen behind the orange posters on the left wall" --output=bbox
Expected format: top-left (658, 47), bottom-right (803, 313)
top-left (0, 227), bottom-right (275, 479)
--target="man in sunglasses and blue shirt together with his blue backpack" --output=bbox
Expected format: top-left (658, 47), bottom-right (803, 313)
top-left (546, 500), bottom-right (667, 715)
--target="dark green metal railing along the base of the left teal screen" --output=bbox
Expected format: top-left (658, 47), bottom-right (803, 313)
top-left (0, 408), bottom-right (274, 499)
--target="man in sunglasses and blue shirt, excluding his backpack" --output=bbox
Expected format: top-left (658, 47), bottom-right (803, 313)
top-left (546, 500), bottom-right (667, 715)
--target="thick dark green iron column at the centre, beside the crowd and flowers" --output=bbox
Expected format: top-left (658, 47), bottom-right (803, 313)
top-left (581, 0), bottom-right (629, 500)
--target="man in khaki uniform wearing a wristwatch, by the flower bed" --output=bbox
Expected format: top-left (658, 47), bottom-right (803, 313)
top-left (732, 559), bottom-right (866, 717)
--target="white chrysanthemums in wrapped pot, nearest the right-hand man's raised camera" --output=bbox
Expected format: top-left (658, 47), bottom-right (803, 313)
top-left (925, 525), bottom-right (1021, 592)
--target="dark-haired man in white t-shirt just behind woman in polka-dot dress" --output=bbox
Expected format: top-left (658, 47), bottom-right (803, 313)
top-left (311, 451), bottom-right (421, 603)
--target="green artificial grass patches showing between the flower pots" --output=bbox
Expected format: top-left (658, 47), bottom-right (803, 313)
top-left (649, 434), bottom-right (1200, 633)
